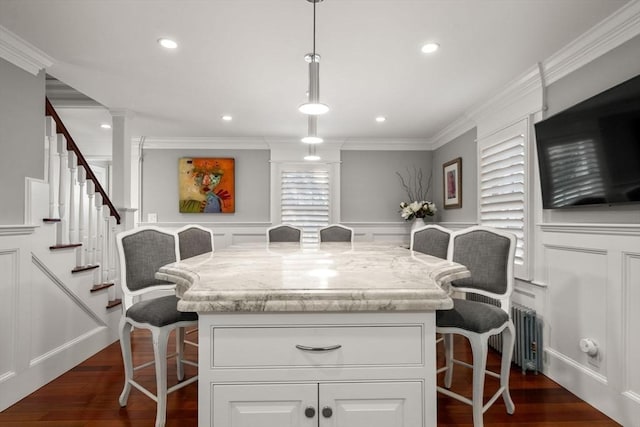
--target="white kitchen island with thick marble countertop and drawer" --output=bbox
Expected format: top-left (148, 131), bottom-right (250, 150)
top-left (156, 242), bottom-right (469, 427)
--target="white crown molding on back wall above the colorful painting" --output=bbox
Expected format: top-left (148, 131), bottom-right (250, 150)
top-left (135, 136), bottom-right (269, 150)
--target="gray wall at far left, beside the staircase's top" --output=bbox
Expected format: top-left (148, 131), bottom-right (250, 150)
top-left (0, 58), bottom-right (45, 225)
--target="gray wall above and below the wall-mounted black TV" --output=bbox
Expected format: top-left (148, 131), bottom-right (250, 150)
top-left (543, 36), bottom-right (640, 224)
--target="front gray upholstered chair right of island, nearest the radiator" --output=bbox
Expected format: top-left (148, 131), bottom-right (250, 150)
top-left (436, 226), bottom-right (516, 427)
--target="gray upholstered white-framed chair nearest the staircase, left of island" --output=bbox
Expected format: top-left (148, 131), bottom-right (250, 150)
top-left (116, 226), bottom-right (198, 427)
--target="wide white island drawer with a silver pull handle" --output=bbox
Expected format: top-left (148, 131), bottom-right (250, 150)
top-left (211, 325), bottom-right (424, 368)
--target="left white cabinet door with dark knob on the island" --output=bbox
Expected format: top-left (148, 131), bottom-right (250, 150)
top-left (211, 384), bottom-right (318, 427)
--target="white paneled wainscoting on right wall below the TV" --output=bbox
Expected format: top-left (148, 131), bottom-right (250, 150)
top-left (536, 224), bottom-right (640, 427)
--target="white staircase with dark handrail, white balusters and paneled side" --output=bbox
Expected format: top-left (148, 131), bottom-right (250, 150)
top-left (0, 100), bottom-right (122, 411)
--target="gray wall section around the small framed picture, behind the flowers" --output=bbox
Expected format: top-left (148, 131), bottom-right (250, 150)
top-left (433, 128), bottom-right (478, 223)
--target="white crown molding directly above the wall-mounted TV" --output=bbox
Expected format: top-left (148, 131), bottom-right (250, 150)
top-left (542, 0), bottom-right (640, 85)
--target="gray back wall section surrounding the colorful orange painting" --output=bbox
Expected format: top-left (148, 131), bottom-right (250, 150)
top-left (140, 150), bottom-right (271, 223)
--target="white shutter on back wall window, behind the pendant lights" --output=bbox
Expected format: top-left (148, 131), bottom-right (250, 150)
top-left (280, 170), bottom-right (330, 243)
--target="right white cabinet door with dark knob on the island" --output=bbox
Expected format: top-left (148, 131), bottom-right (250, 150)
top-left (319, 381), bottom-right (422, 427)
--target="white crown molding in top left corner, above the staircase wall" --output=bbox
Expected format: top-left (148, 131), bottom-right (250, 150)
top-left (0, 25), bottom-right (53, 76)
